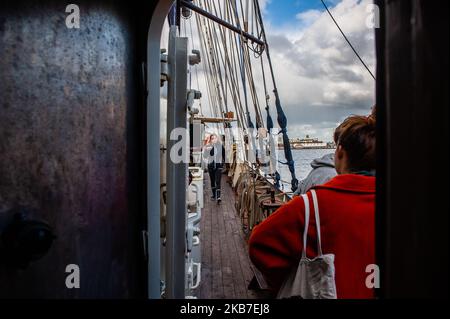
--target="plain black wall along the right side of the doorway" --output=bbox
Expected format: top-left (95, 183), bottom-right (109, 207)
top-left (376, 0), bottom-right (449, 298)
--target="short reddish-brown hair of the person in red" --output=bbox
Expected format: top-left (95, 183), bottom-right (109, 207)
top-left (334, 112), bottom-right (376, 171)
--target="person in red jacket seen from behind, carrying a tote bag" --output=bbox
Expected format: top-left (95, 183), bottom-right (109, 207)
top-left (249, 113), bottom-right (375, 299)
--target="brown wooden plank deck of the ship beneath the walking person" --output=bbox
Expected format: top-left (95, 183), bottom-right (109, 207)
top-left (197, 174), bottom-right (268, 299)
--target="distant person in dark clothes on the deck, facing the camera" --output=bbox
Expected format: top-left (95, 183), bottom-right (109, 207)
top-left (205, 134), bottom-right (225, 202)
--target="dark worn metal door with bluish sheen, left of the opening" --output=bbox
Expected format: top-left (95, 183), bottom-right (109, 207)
top-left (0, 1), bottom-right (159, 298)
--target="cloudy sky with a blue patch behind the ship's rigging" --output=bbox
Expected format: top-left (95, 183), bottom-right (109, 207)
top-left (162, 0), bottom-right (375, 141)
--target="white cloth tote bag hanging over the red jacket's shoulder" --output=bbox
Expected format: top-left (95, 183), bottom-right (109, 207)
top-left (277, 190), bottom-right (337, 299)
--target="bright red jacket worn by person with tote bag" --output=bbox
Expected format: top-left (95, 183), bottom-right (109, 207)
top-left (249, 174), bottom-right (375, 299)
